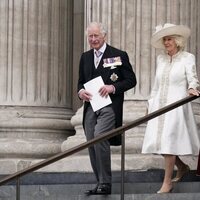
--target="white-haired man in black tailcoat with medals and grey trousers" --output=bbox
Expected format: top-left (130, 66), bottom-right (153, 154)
top-left (78, 22), bottom-right (136, 195)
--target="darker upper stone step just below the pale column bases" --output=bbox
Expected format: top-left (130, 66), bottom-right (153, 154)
top-left (0, 169), bottom-right (200, 185)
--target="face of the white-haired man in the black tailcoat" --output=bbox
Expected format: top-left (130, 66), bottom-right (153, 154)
top-left (88, 26), bottom-right (106, 50)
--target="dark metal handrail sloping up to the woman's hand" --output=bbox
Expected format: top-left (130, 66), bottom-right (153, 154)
top-left (0, 96), bottom-right (199, 198)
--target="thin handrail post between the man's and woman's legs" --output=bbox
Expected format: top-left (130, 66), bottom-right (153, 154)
top-left (121, 133), bottom-right (125, 200)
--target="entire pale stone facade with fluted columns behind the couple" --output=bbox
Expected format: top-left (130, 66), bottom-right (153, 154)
top-left (0, 0), bottom-right (200, 173)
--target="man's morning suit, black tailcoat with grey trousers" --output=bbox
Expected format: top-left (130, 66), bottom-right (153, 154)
top-left (78, 45), bottom-right (136, 183)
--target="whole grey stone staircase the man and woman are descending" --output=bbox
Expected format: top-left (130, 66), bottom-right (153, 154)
top-left (0, 170), bottom-right (200, 200)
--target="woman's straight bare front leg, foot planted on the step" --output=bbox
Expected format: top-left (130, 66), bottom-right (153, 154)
top-left (158, 155), bottom-right (176, 193)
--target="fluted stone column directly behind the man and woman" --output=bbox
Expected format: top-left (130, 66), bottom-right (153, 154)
top-left (65, 0), bottom-right (200, 170)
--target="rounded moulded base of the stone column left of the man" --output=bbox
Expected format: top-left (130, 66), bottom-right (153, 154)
top-left (0, 106), bottom-right (75, 174)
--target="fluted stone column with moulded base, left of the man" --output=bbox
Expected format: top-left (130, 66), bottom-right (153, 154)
top-left (0, 0), bottom-right (74, 174)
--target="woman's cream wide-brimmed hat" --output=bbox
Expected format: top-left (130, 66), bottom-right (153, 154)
top-left (151, 23), bottom-right (190, 49)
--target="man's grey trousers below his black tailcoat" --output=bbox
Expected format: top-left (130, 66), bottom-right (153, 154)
top-left (84, 106), bottom-right (115, 183)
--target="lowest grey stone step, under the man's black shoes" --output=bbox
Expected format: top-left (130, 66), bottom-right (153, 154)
top-left (0, 182), bottom-right (200, 200)
